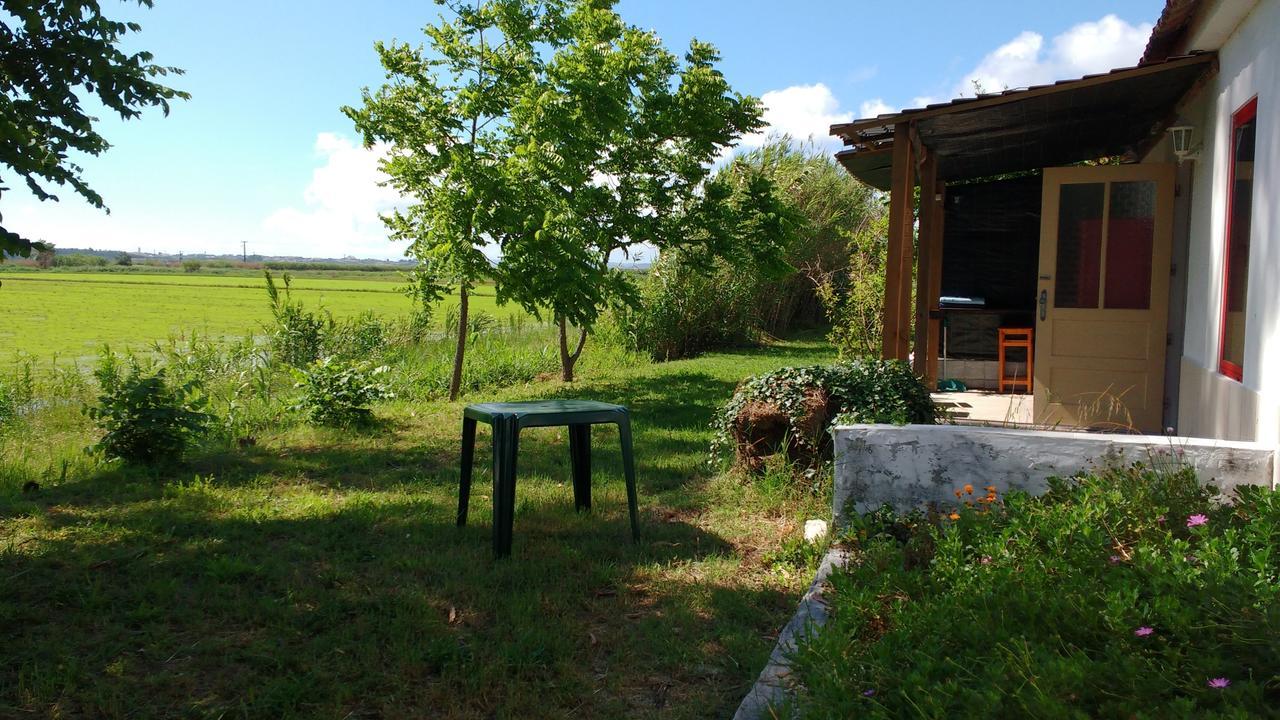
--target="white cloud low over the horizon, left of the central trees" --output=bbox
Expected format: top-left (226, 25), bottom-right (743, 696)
top-left (262, 132), bottom-right (404, 258)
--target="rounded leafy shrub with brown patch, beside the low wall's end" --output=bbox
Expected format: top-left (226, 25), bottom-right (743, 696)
top-left (712, 359), bottom-right (938, 470)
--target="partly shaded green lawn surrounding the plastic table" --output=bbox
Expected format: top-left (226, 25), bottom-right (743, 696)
top-left (0, 335), bottom-right (832, 719)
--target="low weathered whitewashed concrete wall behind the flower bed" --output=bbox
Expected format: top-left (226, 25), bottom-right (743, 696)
top-left (832, 425), bottom-right (1277, 527)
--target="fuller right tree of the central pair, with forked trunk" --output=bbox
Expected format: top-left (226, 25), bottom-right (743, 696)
top-left (497, 0), bottom-right (788, 382)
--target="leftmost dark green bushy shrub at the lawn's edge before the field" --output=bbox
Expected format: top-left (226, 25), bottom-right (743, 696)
top-left (86, 352), bottom-right (211, 465)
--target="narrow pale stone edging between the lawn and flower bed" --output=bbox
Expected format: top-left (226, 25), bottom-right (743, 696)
top-left (733, 548), bottom-right (849, 720)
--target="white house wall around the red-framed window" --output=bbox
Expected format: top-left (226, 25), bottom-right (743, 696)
top-left (1178, 0), bottom-right (1280, 443)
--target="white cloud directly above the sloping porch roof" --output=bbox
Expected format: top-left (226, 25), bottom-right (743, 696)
top-left (955, 15), bottom-right (1151, 95)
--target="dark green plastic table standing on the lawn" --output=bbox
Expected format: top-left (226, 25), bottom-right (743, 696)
top-left (458, 400), bottom-right (640, 557)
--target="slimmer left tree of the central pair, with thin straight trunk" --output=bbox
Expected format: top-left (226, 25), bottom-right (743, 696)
top-left (343, 0), bottom-right (563, 400)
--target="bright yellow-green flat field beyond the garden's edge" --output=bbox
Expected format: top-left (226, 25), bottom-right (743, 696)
top-left (0, 272), bottom-right (524, 360)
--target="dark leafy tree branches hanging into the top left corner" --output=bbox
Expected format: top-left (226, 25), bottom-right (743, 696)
top-left (0, 0), bottom-right (189, 261)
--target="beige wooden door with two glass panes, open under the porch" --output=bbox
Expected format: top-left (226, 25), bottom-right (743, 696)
top-left (1034, 164), bottom-right (1174, 433)
